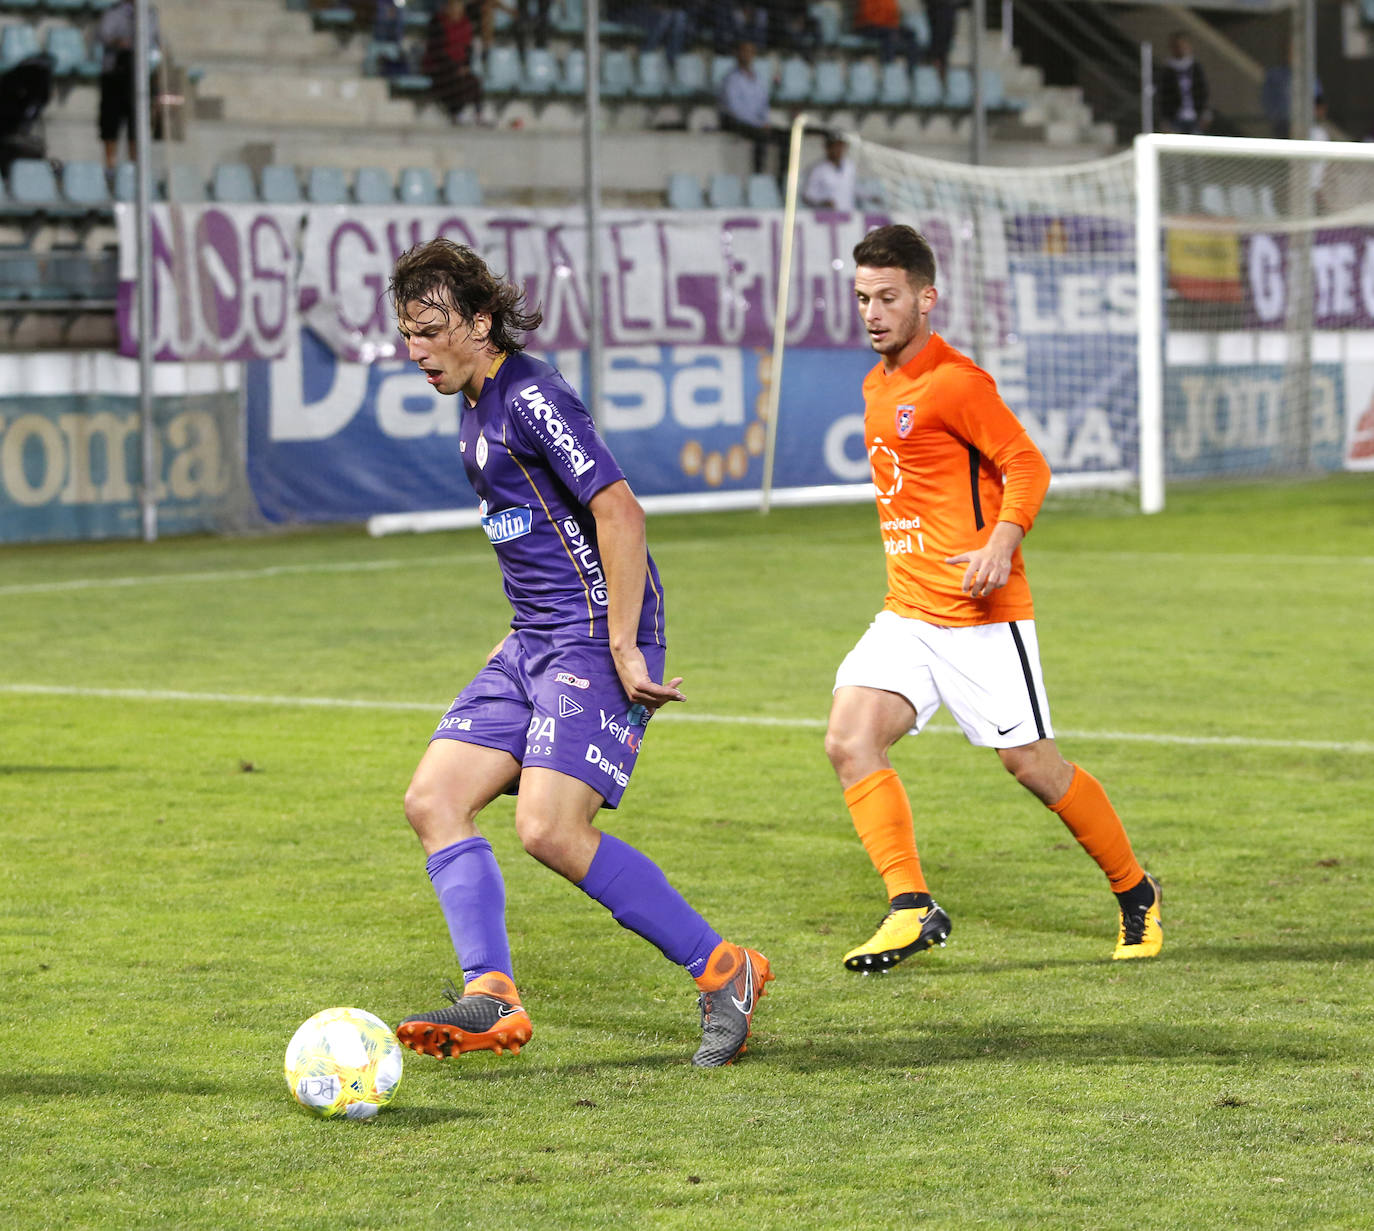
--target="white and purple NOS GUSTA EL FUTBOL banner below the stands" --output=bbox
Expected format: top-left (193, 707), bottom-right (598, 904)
top-left (117, 205), bottom-right (886, 361)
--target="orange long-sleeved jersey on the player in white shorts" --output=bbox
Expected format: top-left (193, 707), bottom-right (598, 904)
top-left (863, 334), bottom-right (1050, 626)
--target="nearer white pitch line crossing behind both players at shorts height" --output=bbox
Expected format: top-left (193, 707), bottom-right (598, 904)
top-left (0, 684), bottom-right (1374, 756)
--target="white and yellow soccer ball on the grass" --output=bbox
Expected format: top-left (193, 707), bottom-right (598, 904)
top-left (286, 1008), bottom-right (401, 1120)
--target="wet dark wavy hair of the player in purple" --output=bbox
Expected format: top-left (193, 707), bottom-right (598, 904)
top-left (386, 239), bottom-right (544, 354)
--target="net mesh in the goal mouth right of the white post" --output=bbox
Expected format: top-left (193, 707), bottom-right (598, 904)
top-left (1154, 140), bottom-right (1374, 479)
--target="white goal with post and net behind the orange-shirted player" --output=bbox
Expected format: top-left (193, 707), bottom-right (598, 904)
top-left (780, 125), bottom-right (1374, 511)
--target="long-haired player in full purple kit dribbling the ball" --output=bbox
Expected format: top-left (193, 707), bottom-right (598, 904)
top-left (389, 239), bottom-right (772, 1068)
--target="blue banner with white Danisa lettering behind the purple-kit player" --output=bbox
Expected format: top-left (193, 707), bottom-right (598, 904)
top-left (246, 330), bottom-right (874, 522)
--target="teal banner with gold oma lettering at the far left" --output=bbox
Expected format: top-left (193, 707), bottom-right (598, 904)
top-left (0, 393), bottom-right (238, 543)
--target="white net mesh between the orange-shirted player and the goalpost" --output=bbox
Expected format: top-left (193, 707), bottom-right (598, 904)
top-left (853, 139), bottom-right (1139, 508)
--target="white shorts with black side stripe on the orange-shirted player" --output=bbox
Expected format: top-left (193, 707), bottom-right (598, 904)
top-left (835, 611), bottom-right (1054, 747)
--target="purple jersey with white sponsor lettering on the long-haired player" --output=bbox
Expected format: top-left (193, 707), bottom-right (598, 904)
top-left (459, 353), bottom-right (665, 646)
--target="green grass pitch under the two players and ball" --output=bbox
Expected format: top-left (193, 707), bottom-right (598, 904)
top-left (0, 475), bottom-right (1374, 1228)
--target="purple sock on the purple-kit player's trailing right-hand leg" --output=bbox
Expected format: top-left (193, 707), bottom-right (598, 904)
top-left (577, 834), bottom-right (720, 978)
